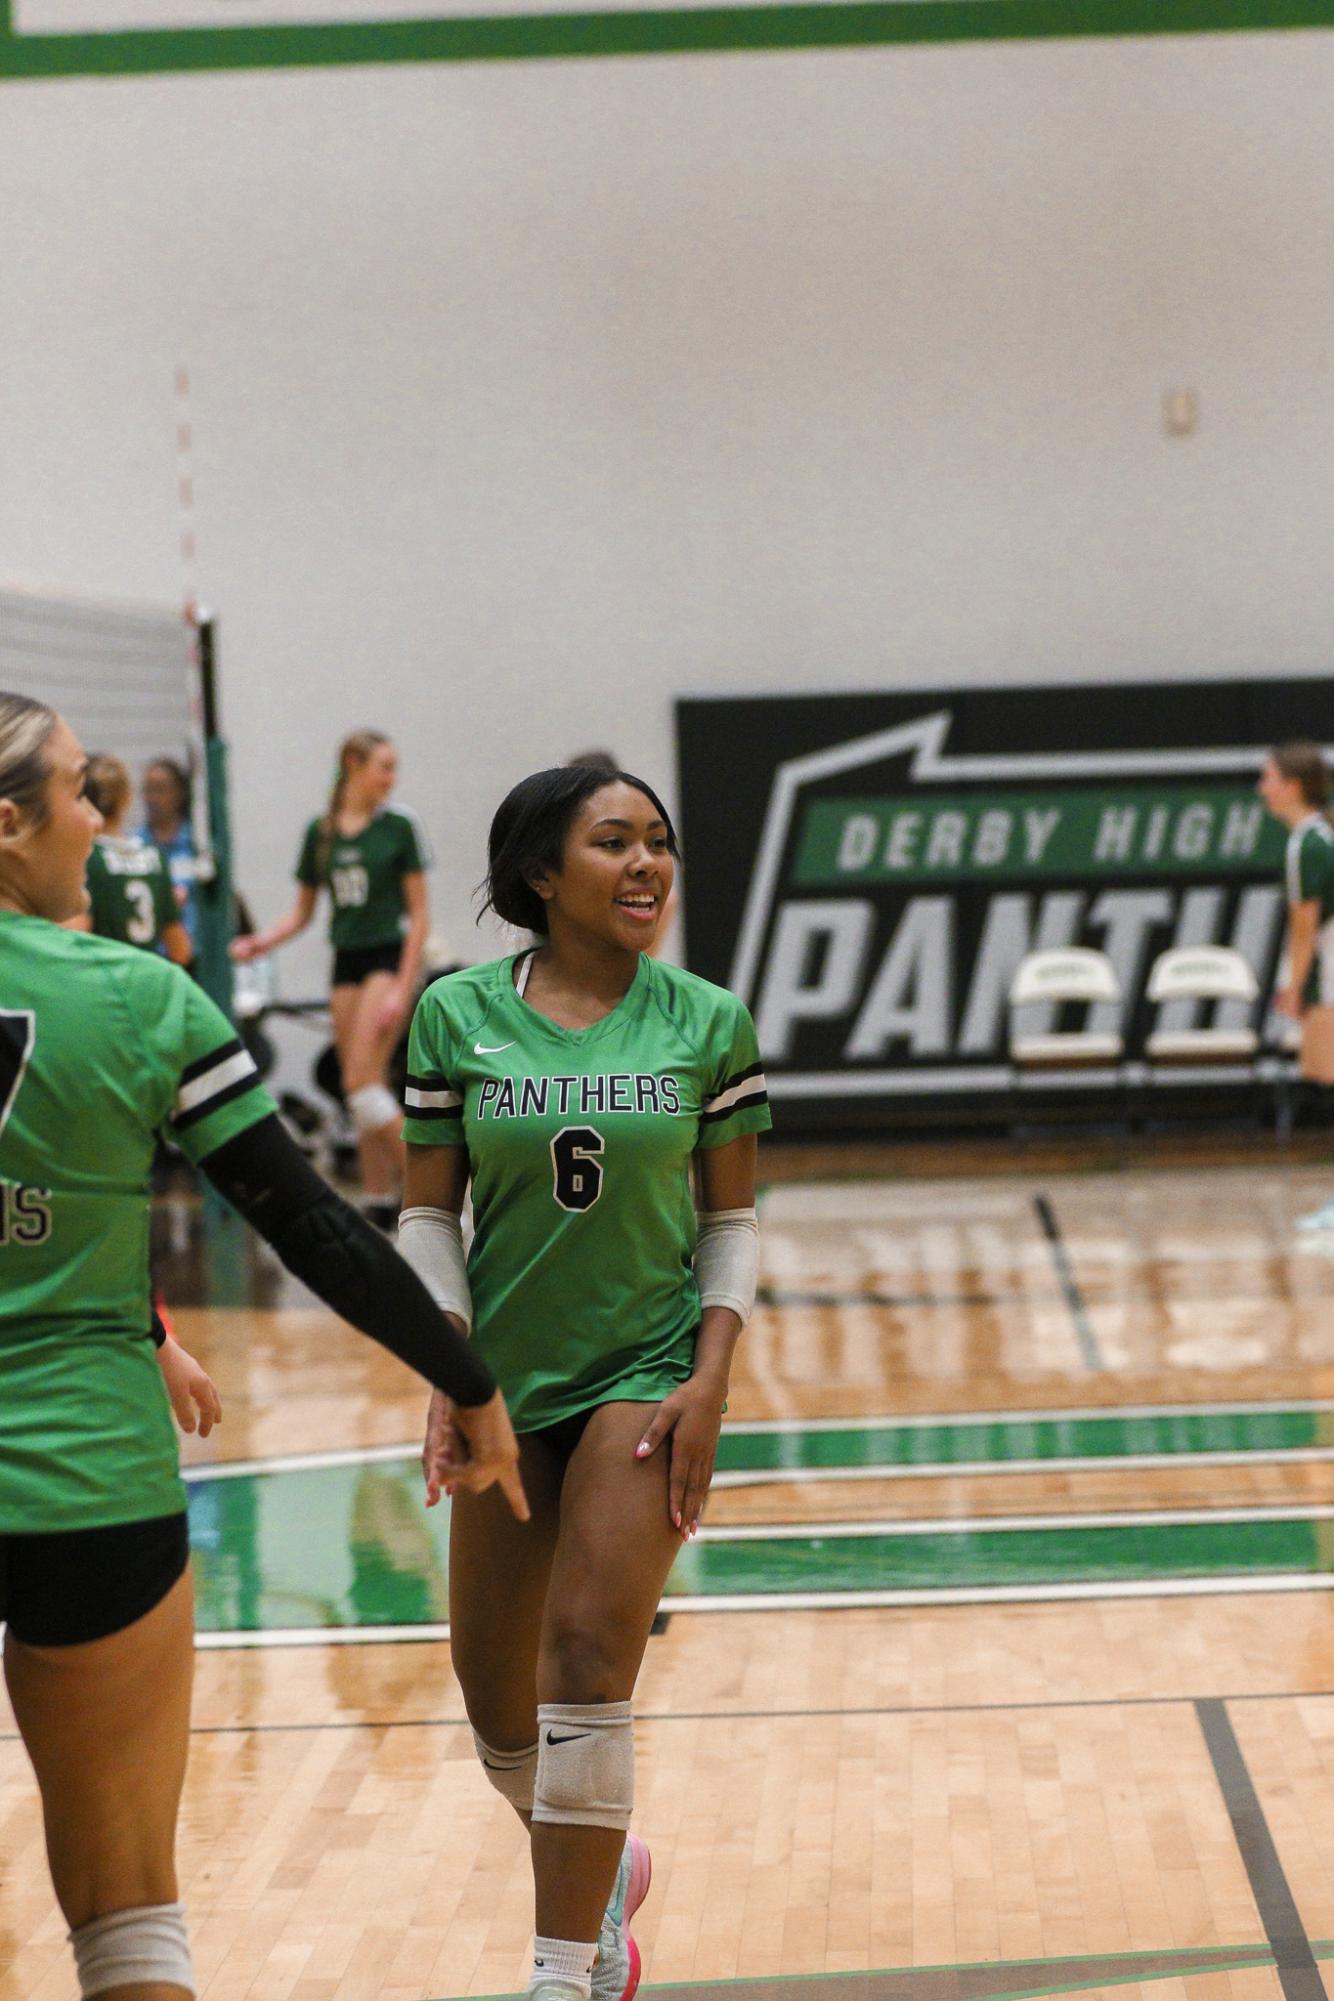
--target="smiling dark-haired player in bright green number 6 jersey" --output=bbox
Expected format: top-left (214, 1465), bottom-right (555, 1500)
top-left (400, 766), bottom-right (770, 2001)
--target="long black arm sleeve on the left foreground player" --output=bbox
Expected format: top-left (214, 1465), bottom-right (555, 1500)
top-left (200, 1113), bottom-right (496, 1407)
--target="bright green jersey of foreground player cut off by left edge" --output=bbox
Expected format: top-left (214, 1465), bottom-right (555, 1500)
top-left (0, 912), bottom-right (274, 1535)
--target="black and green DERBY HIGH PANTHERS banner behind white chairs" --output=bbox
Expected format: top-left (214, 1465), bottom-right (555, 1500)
top-left (678, 680), bottom-right (1334, 1125)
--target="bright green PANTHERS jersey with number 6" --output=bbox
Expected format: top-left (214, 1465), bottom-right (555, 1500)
top-left (404, 954), bottom-right (772, 1431)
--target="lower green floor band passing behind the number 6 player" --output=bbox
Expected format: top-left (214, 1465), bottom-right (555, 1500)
top-left (190, 1461), bottom-right (1334, 1635)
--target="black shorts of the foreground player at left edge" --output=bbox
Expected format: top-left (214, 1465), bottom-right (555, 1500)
top-left (0, 1515), bottom-right (190, 1647)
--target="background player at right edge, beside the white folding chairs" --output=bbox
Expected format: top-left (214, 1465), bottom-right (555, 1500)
top-left (1256, 742), bottom-right (1334, 1229)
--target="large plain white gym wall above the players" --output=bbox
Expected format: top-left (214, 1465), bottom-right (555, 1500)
top-left (0, 34), bottom-right (1334, 1032)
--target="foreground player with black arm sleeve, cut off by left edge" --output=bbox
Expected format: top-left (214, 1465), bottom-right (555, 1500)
top-left (0, 694), bottom-right (526, 2001)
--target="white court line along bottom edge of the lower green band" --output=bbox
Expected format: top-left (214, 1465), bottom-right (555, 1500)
top-left (194, 1571), bottom-right (1334, 1653)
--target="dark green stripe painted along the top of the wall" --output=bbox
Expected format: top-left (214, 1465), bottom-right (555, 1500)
top-left (0, 0), bottom-right (1334, 78)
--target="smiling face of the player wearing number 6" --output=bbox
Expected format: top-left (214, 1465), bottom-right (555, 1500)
top-left (532, 780), bottom-right (676, 952)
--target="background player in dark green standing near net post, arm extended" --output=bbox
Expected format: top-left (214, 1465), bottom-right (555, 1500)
top-left (232, 730), bottom-right (432, 1225)
